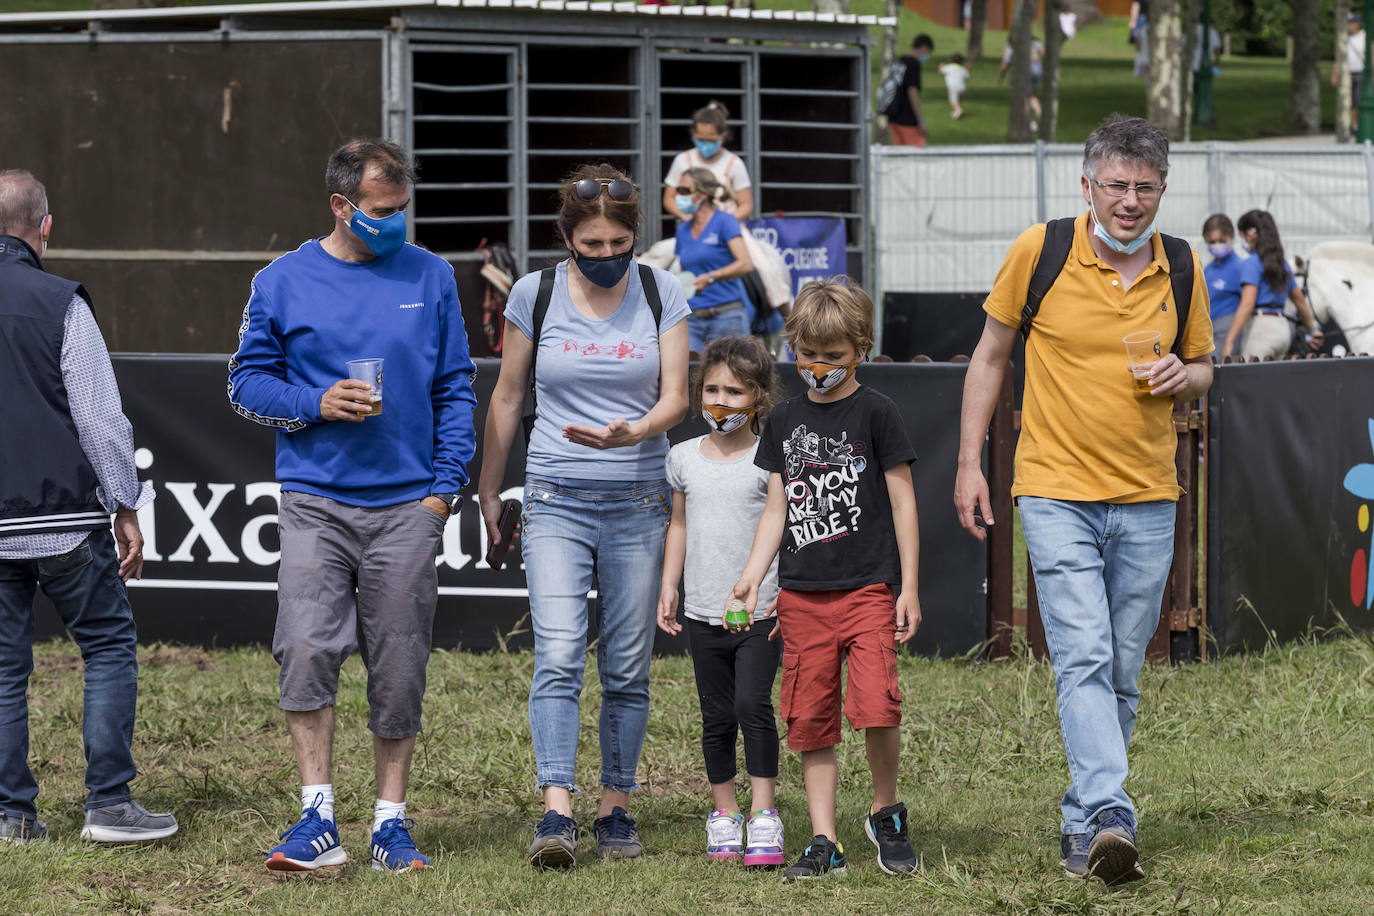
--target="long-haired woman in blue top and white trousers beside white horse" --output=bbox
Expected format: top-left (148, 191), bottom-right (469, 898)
top-left (1220, 210), bottom-right (1322, 360)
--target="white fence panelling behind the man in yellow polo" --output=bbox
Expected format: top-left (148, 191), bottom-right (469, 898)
top-left (872, 143), bottom-right (1374, 301)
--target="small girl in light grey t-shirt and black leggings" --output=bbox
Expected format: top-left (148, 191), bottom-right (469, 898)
top-left (658, 338), bottom-right (785, 867)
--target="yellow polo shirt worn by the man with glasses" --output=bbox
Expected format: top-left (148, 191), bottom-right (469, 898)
top-left (982, 213), bottom-right (1213, 503)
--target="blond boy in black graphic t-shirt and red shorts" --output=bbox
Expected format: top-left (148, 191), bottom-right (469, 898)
top-left (732, 279), bottom-right (921, 882)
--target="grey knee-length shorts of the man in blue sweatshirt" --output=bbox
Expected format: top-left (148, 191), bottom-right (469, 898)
top-left (272, 490), bottom-right (445, 739)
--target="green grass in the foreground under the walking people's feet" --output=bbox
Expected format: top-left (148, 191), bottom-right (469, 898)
top-left (0, 626), bottom-right (1374, 915)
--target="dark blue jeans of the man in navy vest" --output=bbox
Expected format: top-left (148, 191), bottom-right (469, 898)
top-left (0, 529), bottom-right (139, 817)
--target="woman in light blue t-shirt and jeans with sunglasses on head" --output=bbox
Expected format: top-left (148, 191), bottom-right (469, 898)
top-left (477, 163), bottom-right (688, 868)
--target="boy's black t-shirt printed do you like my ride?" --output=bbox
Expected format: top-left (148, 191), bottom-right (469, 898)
top-left (754, 386), bottom-right (916, 592)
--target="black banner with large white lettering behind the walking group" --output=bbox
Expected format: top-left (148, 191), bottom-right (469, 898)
top-left (40, 354), bottom-right (987, 655)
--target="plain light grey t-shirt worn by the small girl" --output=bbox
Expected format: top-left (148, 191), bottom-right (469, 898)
top-left (666, 435), bottom-right (778, 625)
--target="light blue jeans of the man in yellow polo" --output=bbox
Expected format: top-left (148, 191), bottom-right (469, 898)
top-left (1018, 496), bottom-right (1176, 834)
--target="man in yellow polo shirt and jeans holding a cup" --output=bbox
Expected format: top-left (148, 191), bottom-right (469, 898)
top-left (955, 115), bottom-right (1212, 884)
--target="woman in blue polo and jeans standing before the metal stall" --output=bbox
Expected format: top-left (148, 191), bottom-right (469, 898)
top-left (675, 168), bottom-right (754, 353)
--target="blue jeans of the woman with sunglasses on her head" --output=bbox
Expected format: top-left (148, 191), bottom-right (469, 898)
top-left (521, 478), bottom-right (672, 792)
